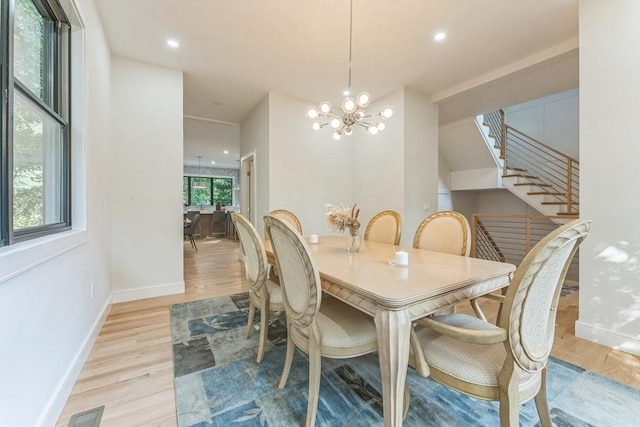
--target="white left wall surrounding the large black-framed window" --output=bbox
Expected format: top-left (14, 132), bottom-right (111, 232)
top-left (0, 2), bottom-right (111, 426)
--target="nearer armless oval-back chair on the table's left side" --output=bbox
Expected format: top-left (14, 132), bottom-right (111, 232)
top-left (264, 216), bottom-right (409, 427)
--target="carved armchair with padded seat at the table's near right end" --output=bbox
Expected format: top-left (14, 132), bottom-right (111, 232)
top-left (415, 219), bottom-right (591, 427)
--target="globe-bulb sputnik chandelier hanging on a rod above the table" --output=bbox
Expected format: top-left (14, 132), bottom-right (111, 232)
top-left (307, 0), bottom-right (393, 140)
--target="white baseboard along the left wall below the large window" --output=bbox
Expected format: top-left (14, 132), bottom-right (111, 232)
top-left (37, 298), bottom-right (111, 426)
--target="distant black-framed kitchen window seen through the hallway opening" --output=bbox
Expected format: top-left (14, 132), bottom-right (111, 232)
top-left (182, 176), bottom-right (233, 206)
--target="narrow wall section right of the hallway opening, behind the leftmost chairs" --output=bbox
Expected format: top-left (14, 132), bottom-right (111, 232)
top-left (240, 95), bottom-right (270, 233)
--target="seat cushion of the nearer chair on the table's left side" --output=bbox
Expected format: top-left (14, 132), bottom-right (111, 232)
top-left (316, 296), bottom-right (378, 358)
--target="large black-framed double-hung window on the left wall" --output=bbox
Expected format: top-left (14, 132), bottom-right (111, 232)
top-left (0, 0), bottom-right (71, 246)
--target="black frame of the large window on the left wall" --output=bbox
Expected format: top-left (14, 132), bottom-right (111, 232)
top-left (0, 0), bottom-right (72, 247)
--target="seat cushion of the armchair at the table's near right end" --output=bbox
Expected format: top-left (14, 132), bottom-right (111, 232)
top-left (416, 314), bottom-right (506, 386)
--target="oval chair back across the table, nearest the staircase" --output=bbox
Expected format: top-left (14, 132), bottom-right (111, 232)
top-left (413, 211), bottom-right (471, 256)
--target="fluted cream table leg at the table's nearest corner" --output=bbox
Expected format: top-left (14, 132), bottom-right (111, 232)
top-left (375, 308), bottom-right (411, 427)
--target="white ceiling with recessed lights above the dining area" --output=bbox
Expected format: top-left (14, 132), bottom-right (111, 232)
top-left (95, 0), bottom-right (578, 171)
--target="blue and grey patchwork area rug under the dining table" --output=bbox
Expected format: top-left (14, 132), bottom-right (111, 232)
top-left (171, 294), bottom-right (640, 427)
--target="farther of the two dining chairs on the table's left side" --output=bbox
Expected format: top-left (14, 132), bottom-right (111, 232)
top-left (231, 212), bottom-right (284, 363)
